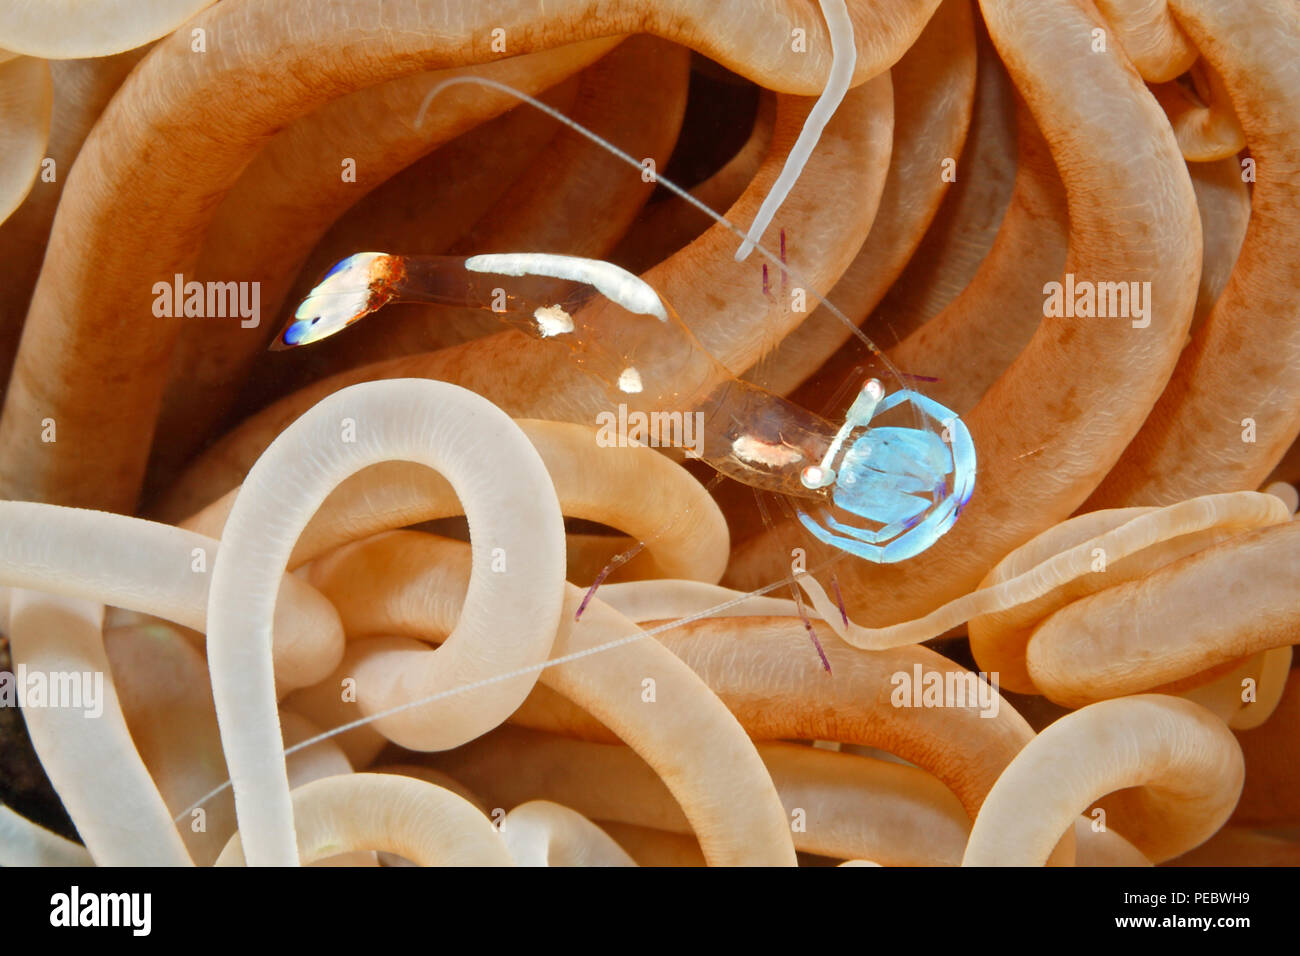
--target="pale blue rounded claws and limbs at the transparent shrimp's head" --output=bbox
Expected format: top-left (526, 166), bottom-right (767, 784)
top-left (798, 389), bottom-right (975, 564)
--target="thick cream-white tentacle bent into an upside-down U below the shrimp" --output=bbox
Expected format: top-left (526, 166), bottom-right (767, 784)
top-left (208, 380), bottom-right (564, 865)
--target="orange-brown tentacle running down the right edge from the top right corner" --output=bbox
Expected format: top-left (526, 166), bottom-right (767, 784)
top-left (1087, 0), bottom-right (1300, 507)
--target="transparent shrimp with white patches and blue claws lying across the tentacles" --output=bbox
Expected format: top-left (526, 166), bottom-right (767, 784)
top-left (272, 252), bottom-right (975, 563)
